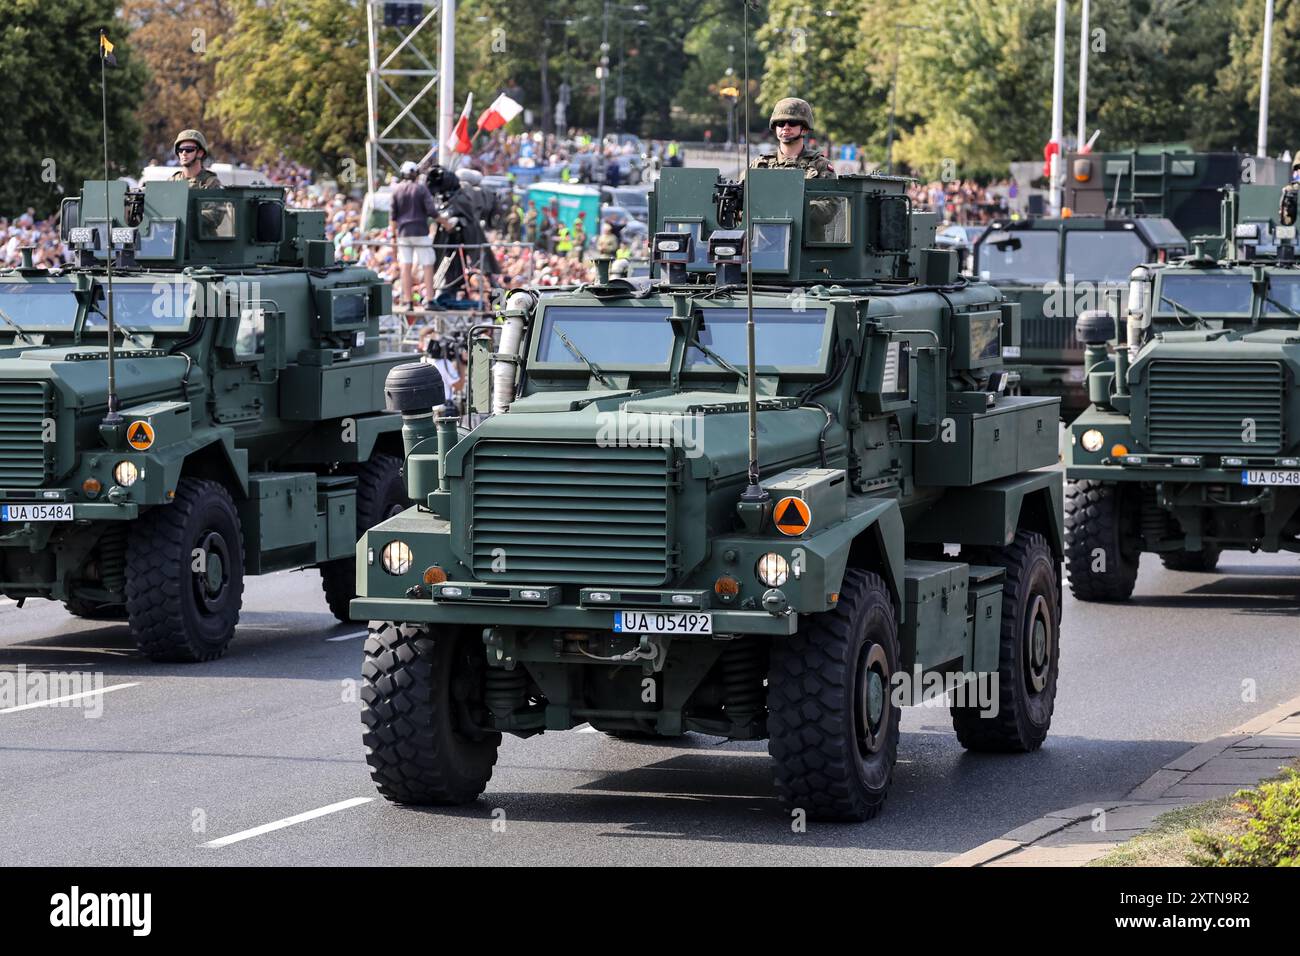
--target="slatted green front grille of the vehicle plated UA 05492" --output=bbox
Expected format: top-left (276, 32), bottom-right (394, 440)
top-left (469, 440), bottom-right (670, 587)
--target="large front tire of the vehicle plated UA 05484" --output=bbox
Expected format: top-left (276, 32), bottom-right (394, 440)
top-left (126, 477), bottom-right (244, 662)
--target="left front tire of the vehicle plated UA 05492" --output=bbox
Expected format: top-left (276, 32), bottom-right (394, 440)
top-left (361, 622), bottom-right (501, 805)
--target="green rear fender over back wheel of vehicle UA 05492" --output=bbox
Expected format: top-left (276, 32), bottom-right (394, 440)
top-left (907, 471), bottom-right (1065, 561)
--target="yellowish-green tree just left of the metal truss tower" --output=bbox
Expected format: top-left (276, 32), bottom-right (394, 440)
top-left (207, 0), bottom-right (368, 177)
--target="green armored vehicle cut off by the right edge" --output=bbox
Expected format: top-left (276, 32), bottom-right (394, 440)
top-left (1066, 186), bottom-right (1300, 601)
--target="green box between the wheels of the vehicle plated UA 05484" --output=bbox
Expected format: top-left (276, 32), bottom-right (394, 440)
top-left (238, 472), bottom-right (316, 574)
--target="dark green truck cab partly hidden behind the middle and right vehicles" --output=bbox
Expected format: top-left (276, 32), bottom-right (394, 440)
top-left (974, 216), bottom-right (1188, 421)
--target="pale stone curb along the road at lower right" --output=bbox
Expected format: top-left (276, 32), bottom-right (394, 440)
top-left (939, 696), bottom-right (1300, 866)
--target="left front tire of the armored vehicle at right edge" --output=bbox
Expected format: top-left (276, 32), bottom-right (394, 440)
top-left (1065, 481), bottom-right (1141, 601)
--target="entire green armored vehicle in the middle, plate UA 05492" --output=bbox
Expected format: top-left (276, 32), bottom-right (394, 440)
top-left (352, 169), bottom-right (1062, 819)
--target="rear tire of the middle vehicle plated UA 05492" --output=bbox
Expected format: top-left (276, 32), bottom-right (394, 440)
top-left (950, 531), bottom-right (1061, 753)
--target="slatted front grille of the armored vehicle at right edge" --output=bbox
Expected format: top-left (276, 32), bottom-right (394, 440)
top-left (1147, 359), bottom-right (1284, 454)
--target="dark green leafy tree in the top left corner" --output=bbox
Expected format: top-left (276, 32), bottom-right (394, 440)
top-left (0, 0), bottom-right (147, 216)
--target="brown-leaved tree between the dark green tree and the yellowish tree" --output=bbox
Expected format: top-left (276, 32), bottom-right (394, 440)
top-left (122, 0), bottom-right (239, 159)
